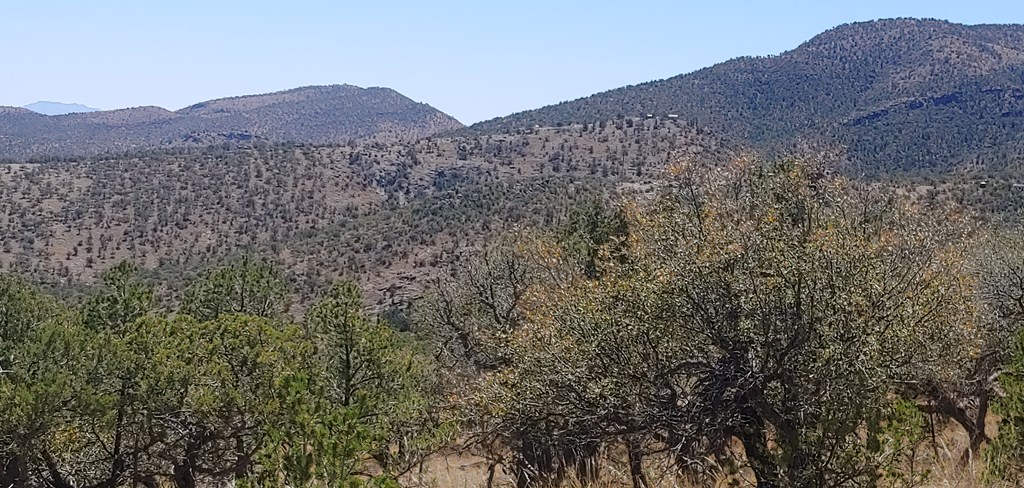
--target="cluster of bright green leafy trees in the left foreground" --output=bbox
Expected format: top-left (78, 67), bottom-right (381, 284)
top-left (0, 260), bottom-right (442, 488)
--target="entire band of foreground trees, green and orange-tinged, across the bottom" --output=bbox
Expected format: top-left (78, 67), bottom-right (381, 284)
top-left (6, 160), bottom-right (1024, 488)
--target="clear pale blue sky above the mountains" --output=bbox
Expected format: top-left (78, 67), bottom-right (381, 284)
top-left (6, 0), bottom-right (1024, 123)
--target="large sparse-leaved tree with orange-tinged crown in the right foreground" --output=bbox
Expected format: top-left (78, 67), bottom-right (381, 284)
top-left (427, 157), bottom-right (982, 487)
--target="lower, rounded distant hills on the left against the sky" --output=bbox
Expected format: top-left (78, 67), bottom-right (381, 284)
top-left (0, 85), bottom-right (462, 161)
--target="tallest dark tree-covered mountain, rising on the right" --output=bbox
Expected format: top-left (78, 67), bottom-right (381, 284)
top-left (469, 18), bottom-right (1024, 171)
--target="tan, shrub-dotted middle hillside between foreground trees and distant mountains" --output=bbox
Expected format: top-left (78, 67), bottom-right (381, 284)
top-left (0, 116), bottom-right (733, 300)
